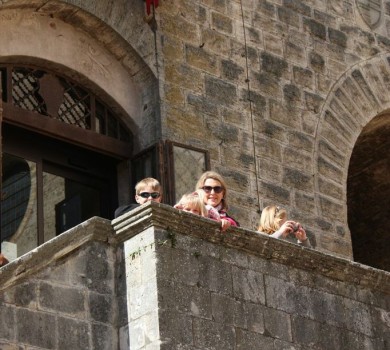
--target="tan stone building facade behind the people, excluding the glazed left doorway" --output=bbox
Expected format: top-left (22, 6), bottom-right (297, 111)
top-left (0, 0), bottom-right (390, 268)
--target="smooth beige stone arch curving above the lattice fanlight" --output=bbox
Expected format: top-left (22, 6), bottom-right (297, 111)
top-left (0, 0), bottom-right (159, 150)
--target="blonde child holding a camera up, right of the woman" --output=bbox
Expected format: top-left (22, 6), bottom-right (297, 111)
top-left (258, 205), bottom-right (311, 247)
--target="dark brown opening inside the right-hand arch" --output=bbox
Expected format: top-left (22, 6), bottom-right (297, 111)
top-left (347, 114), bottom-right (390, 271)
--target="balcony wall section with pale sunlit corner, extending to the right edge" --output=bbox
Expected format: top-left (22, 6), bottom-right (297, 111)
top-left (113, 203), bottom-right (390, 350)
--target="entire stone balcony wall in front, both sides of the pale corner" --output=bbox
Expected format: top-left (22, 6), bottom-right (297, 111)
top-left (0, 202), bottom-right (390, 350)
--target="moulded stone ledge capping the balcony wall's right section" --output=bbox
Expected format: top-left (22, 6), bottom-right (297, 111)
top-left (112, 202), bottom-right (390, 294)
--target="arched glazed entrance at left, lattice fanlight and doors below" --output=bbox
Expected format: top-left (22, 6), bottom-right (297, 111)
top-left (0, 65), bottom-right (132, 259)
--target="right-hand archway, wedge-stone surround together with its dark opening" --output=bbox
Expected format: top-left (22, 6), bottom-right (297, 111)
top-left (314, 54), bottom-right (390, 267)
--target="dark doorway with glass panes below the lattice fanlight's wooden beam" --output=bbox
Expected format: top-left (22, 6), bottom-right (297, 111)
top-left (1, 123), bottom-right (119, 256)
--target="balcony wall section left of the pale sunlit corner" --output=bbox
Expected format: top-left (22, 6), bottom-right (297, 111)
top-left (0, 218), bottom-right (127, 350)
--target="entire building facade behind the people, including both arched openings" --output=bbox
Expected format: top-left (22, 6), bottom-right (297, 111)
top-left (0, 0), bottom-right (390, 348)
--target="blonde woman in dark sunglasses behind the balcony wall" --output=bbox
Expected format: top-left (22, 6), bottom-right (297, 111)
top-left (195, 171), bottom-right (240, 231)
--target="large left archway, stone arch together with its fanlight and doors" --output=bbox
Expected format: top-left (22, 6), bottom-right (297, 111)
top-left (0, 2), bottom-right (158, 256)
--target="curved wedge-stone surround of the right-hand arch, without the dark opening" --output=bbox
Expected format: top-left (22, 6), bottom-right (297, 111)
top-left (314, 54), bottom-right (390, 258)
